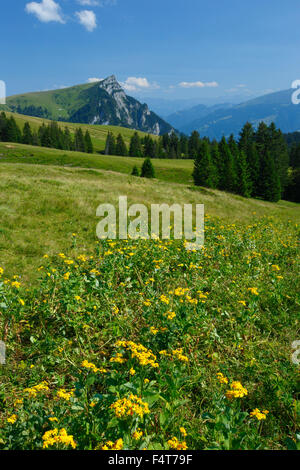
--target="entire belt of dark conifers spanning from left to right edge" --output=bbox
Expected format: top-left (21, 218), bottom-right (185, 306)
top-left (0, 112), bottom-right (300, 202)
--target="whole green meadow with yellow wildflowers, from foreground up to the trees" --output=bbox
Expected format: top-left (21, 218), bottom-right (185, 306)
top-left (0, 141), bottom-right (300, 450)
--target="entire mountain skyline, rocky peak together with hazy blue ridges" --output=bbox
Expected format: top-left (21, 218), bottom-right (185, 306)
top-left (2, 75), bottom-right (300, 140)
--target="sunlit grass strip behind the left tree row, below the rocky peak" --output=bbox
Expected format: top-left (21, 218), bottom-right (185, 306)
top-left (2, 112), bottom-right (157, 152)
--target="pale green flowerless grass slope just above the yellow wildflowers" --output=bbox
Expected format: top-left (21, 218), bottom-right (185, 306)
top-left (0, 157), bottom-right (299, 281)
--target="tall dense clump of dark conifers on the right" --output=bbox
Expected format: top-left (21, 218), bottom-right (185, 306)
top-left (193, 122), bottom-right (289, 202)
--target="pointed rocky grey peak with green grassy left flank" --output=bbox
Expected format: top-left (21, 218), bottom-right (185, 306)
top-left (6, 75), bottom-right (172, 135)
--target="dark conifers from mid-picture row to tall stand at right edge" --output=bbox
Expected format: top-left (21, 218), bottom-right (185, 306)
top-left (105, 122), bottom-right (300, 202)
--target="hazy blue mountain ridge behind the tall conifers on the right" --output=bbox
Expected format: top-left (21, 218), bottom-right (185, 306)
top-left (167, 89), bottom-right (300, 139)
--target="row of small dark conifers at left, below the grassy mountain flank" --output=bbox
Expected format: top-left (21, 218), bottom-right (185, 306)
top-left (0, 113), bottom-right (94, 153)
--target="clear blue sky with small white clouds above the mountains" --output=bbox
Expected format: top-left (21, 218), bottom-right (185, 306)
top-left (0, 0), bottom-right (300, 100)
